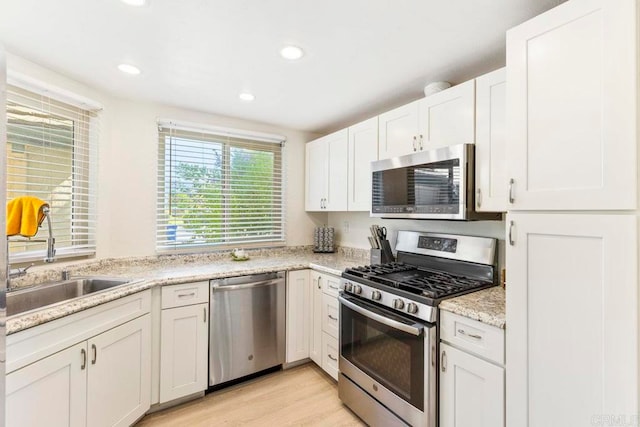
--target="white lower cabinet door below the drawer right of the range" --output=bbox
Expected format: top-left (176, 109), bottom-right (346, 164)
top-left (440, 343), bottom-right (504, 427)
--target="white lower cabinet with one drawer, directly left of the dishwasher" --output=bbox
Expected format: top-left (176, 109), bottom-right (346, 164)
top-left (160, 282), bottom-right (209, 403)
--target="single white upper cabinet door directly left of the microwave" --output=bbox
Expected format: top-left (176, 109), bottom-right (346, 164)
top-left (347, 117), bottom-right (378, 212)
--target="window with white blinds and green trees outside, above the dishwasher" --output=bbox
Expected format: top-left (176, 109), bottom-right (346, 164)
top-left (156, 122), bottom-right (284, 251)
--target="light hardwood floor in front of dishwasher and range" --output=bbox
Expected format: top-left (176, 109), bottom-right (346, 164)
top-left (136, 363), bottom-right (365, 427)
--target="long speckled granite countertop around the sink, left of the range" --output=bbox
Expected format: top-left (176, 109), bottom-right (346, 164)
top-left (6, 247), bottom-right (369, 335)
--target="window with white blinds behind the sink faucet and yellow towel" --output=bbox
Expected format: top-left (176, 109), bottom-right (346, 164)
top-left (7, 80), bottom-right (97, 262)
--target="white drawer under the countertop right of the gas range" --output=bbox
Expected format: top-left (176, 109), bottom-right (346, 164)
top-left (440, 311), bottom-right (504, 365)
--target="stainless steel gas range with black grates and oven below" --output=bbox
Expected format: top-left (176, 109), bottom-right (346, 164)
top-left (338, 231), bottom-right (497, 427)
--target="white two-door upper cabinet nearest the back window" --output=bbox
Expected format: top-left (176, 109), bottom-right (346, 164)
top-left (305, 129), bottom-right (348, 211)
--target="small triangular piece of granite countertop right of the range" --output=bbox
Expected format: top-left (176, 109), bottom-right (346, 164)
top-left (438, 286), bottom-right (506, 329)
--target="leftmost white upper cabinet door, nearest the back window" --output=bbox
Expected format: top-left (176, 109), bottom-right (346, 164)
top-left (305, 138), bottom-right (327, 211)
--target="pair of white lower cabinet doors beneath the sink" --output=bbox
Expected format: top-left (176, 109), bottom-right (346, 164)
top-left (6, 314), bottom-right (151, 427)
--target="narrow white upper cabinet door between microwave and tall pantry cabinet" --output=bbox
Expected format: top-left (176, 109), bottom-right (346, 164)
top-left (475, 68), bottom-right (508, 212)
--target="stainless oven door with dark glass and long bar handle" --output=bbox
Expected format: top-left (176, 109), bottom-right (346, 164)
top-left (339, 294), bottom-right (436, 426)
